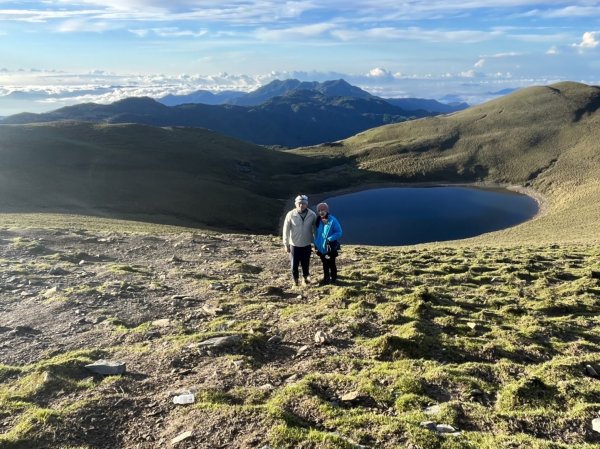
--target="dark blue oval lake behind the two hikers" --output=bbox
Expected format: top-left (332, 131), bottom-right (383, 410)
top-left (325, 187), bottom-right (538, 245)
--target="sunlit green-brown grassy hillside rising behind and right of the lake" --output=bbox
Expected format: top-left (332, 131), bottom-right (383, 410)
top-left (297, 83), bottom-right (600, 242)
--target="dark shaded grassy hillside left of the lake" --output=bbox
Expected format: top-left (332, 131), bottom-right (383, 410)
top-left (0, 122), bottom-right (372, 232)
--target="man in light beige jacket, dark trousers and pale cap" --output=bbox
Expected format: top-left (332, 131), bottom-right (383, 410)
top-left (283, 195), bottom-right (317, 285)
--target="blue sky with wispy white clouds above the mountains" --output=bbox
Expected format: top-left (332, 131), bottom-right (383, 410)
top-left (0, 0), bottom-right (600, 116)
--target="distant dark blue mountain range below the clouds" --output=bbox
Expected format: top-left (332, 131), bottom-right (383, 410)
top-left (3, 80), bottom-right (467, 147)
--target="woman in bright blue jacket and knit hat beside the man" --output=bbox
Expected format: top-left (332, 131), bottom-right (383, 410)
top-left (315, 203), bottom-right (342, 284)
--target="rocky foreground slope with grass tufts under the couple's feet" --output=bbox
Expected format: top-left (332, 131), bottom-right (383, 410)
top-left (0, 228), bottom-right (600, 449)
